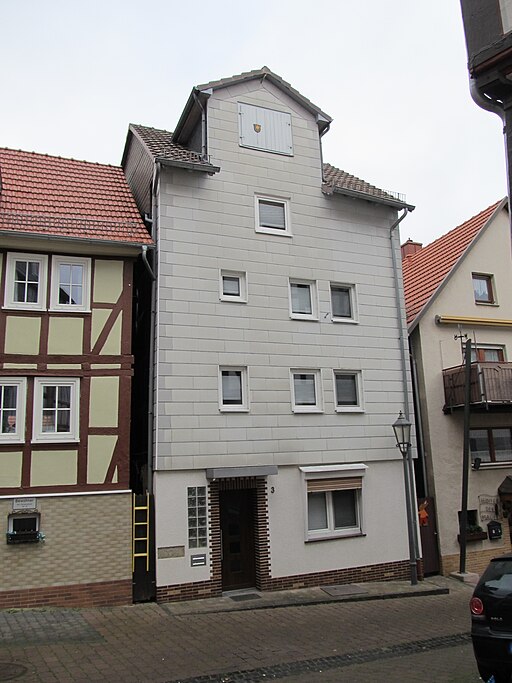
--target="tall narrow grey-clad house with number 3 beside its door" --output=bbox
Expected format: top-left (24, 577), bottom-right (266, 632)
top-left (122, 67), bottom-right (412, 601)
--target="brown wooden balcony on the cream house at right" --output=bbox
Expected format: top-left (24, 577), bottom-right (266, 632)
top-left (443, 363), bottom-right (512, 413)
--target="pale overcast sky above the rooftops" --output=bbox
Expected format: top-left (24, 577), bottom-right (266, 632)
top-left (0, 0), bottom-right (506, 244)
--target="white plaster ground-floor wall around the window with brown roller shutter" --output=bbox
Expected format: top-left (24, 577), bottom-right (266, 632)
top-left (268, 458), bottom-right (409, 578)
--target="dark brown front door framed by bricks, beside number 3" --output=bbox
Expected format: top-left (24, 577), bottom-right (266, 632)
top-left (220, 489), bottom-right (256, 590)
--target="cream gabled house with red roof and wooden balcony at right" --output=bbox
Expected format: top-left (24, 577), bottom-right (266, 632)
top-left (402, 200), bottom-right (512, 574)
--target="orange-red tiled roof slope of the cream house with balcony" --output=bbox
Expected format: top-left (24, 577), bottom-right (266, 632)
top-left (402, 200), bottom-right (506, 325)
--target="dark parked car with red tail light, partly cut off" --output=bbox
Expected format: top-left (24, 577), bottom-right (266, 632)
top-left (470, 555), bottom-right (512, 683)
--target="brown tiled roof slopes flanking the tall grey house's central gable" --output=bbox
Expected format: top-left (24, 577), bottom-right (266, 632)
top-left (130, 123), bottom-right (405, 207)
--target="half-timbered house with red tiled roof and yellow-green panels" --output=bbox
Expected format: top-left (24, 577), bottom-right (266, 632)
top-left (0, 149), bottom-right (152, 607)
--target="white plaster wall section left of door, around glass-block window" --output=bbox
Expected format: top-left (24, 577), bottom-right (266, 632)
top-left (154, 471), bottom-right (210, 586)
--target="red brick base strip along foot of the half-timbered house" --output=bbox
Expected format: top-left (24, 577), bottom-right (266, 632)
top-left (0, 579), bottom-right (133, 609)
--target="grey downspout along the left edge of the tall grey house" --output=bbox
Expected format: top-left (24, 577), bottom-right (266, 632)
top-left (142, 161), bottom-right (160, 493)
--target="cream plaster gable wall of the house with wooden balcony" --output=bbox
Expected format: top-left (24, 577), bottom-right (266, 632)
top-left (414, 211), bottom-right (512, 555)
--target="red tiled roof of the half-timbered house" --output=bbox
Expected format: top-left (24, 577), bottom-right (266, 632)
top-left (0, 148), bottom-right (152, 244)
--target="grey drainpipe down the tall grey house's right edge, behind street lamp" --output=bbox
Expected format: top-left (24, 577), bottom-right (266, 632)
top-left (389, 207), bottom-right (420, 562)
